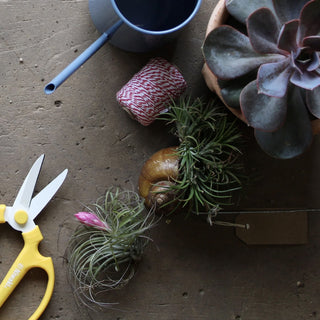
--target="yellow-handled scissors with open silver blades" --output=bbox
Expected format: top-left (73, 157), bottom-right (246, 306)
top-left (0, 155), bottom-right (68, 320)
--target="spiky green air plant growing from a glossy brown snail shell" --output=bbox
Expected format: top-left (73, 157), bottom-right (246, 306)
top-left (139, 98), bottom-right (241, 216)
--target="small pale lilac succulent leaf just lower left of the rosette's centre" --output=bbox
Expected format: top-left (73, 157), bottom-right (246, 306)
top-left (258, 58), bottom-right (293, 98)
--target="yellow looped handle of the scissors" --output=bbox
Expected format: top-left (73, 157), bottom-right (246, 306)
top-left (0, 225), bottom-right (54, 320)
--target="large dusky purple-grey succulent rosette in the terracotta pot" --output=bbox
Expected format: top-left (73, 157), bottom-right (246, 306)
top-left (202, 0), bottom-right (320, 159)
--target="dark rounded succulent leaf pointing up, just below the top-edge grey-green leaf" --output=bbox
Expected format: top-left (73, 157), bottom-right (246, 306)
top-left (247, 8), bottom-right (281, 54)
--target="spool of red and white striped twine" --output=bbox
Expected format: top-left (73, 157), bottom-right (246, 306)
top-left (116, 57), bottom-right (187, 126)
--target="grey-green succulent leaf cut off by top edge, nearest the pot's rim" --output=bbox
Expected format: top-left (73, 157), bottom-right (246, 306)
top-left (226, 0), bottom-right (274, 24)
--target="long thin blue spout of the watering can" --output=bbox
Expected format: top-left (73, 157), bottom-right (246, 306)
top-left (44, 20), bottom-right (123, 94)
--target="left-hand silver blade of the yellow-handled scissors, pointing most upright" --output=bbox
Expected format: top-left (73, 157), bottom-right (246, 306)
top-left (13, 154), bottom-right (44, 209)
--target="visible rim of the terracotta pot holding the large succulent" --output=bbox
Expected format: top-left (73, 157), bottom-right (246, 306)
top-left (202, 0), bottom-right (320, 135)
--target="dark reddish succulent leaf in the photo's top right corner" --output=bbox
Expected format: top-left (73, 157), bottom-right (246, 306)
top-left (299, 0), bottom-right (320, 43)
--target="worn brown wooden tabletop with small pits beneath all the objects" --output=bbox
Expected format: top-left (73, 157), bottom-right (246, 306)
top-left (0, 0), bottom-right (320, 320)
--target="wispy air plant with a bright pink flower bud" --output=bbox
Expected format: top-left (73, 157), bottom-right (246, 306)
top-left (67, 188), bottom-right (155, 308)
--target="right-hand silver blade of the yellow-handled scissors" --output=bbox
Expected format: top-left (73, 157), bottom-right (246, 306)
top-left (29, 169), bottom-right (68, 219)
